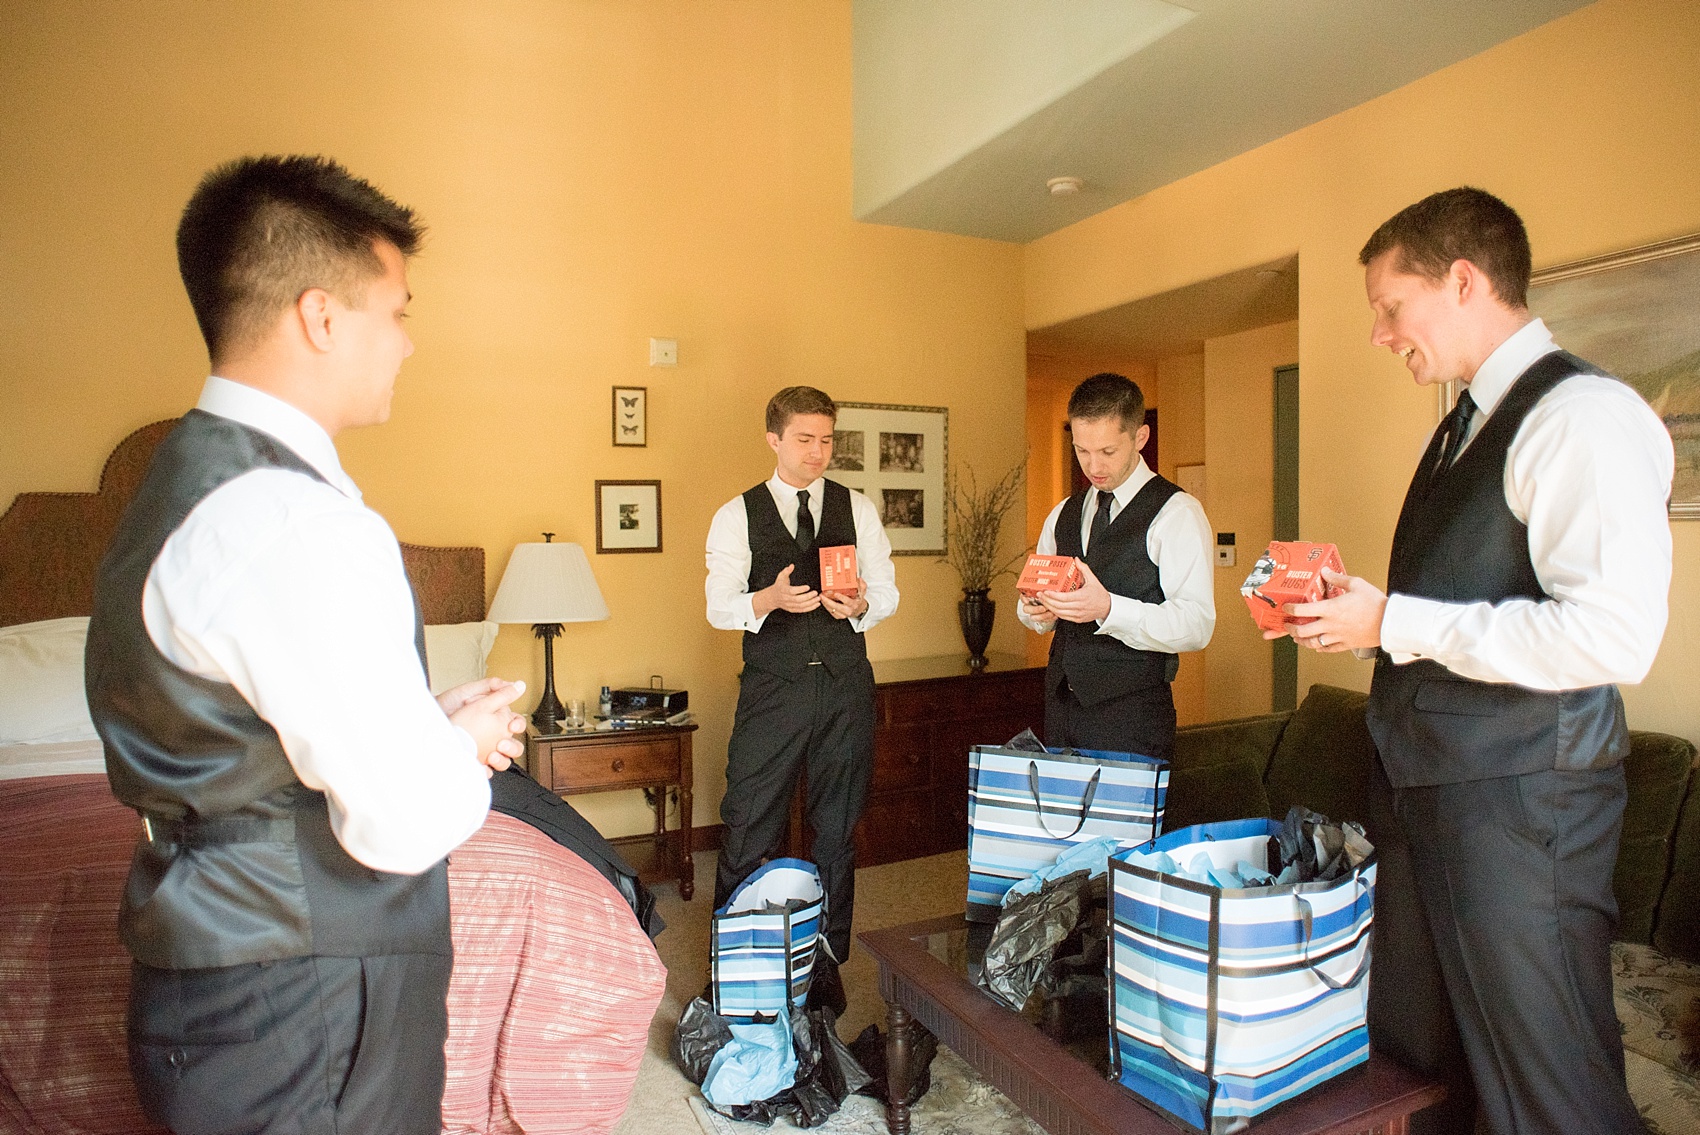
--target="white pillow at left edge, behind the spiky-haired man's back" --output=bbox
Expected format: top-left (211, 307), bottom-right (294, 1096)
top-left (0, 617), bottom-right (97, 744)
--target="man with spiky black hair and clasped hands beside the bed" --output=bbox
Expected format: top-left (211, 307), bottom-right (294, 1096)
top-left (87, 158), bottom-right (524, 1135)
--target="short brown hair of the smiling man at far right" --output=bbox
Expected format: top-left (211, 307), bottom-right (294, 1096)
top-left (1358, 185), bottom-right (1532, 308)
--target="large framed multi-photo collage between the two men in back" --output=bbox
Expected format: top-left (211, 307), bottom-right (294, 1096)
top-left (826, 403), bottom-right (950, 556)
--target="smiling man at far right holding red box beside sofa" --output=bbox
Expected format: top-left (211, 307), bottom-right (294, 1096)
top-left (1290, 189), bottom-right (1673, 1135)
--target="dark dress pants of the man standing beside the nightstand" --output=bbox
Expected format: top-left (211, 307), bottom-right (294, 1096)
top-left (714, 661), bottom-right (874, 962)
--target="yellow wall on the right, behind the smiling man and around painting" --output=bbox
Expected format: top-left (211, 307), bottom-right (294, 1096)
top-left (1025, 0), bottom-right (1700, 741)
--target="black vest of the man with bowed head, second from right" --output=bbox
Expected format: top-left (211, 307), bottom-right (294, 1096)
top-left (1046, 476), bottom-right (1180, 705)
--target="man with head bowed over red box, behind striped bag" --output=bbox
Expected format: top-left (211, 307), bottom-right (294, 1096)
top-left (1017, 374), bottom-right (1216, 759)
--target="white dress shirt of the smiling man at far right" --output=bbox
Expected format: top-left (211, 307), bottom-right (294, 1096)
top-left (1380, 319), bottom-right (1675, 690)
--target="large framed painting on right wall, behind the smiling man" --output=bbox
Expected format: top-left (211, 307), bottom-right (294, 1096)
top-left (1528, 234), bottom-right (1700, 520)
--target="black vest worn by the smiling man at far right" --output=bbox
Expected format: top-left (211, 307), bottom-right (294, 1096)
top-left (1367, 352), bottom-right (1629, 788)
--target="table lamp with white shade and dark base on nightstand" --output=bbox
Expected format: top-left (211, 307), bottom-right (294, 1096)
top-left (488, 532), bottom-right (609, 732)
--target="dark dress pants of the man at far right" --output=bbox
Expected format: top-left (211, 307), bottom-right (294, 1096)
top-left (1377, 768), bottom-right (1644, 1135)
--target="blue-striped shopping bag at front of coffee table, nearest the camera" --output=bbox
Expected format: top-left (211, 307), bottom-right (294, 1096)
top-left (1108, 819), bottom-right (1375, 1135)
